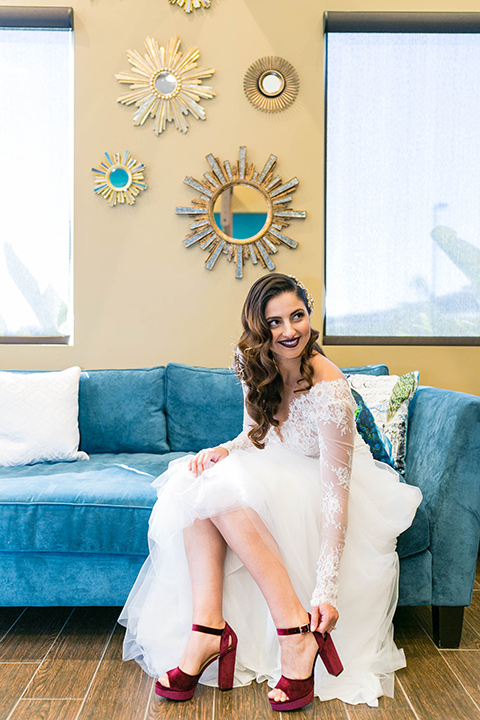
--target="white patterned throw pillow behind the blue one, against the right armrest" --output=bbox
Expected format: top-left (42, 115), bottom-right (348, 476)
top-left (348, 370), bottom-right (419, 473)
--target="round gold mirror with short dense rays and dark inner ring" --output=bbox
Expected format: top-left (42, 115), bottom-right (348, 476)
top-left (243, 56), bottom-right (300, 112)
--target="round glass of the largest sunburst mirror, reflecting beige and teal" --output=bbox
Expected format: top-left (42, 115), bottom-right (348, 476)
top-left (213, 183), bottom-right (268, 240)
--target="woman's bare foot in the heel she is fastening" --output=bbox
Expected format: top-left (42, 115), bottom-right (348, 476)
top-left (268, 619), bottom-right (318, 703)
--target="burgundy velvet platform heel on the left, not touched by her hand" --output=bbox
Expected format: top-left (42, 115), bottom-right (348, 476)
top-left (155, 623), bottom-right (237, 701)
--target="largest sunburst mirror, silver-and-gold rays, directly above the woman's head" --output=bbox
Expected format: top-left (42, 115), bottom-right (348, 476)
top-left (176, 146), bottom-right (306, 279)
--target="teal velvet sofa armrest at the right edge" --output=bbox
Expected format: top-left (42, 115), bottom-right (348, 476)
top-left (405, 387), bottom-right (480, 606)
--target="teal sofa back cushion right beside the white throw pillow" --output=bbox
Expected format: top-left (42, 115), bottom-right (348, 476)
top-left (79, 367), bottom-right (169, 453)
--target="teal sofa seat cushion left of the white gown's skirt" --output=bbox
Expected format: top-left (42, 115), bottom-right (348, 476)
top-left (0, 453), bottom-right (183, 555)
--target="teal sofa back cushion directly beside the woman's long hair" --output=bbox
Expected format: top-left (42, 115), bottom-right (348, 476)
top-left (165, 363), bottom-right (243, 452)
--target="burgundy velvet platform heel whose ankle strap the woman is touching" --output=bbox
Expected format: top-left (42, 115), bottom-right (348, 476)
top-left (270, 623), bottom-right (343, 712)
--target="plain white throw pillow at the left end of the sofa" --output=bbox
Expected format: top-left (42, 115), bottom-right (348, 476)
top-left (0, 367), bottom-right (89, 467)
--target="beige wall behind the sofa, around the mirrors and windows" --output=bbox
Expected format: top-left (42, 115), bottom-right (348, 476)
top-left (0, 0), bottom-right (480, 394)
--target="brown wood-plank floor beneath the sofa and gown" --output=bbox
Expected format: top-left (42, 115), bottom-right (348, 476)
top-left (0, 571), bottom-right (480, 720)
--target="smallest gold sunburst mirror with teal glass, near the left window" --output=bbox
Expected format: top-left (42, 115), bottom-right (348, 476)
top-left (92, 150), bottom-right (147, 207)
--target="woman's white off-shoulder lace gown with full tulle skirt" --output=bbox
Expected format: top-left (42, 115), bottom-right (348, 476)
top-left (120, 379), bottom-right (422, 706)
